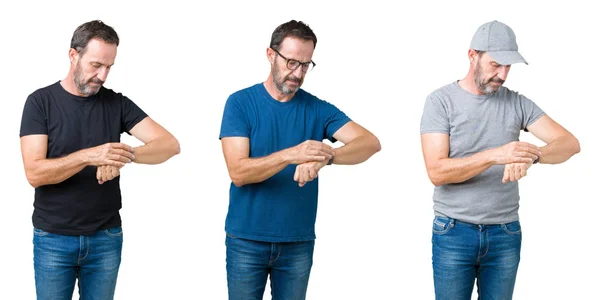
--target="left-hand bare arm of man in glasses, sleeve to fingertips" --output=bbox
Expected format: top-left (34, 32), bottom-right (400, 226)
top-left (221, 137), bottom-right (333, 187)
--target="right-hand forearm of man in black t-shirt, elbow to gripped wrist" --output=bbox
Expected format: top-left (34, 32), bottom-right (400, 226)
top-left (133, 136), bottom-right (180, 165)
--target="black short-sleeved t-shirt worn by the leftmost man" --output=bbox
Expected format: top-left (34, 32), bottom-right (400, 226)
top-left (20, 82), bottom-right (147, 235)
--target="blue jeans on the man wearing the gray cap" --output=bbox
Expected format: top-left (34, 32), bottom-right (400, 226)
top-left (431, 217), bottom-right (521, 300)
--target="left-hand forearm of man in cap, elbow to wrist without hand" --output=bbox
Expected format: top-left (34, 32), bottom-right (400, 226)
top-left (427, 150), bottom-right (493, 186)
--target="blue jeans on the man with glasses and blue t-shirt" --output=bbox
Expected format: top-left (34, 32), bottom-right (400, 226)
top-left (225, 234), bottom-right (315, 300)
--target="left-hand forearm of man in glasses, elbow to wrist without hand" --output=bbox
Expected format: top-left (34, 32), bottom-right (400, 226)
top-left (229, 150), bottom-right (290, 187)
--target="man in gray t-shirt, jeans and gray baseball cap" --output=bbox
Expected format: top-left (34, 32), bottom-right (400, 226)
top-left (421, 21), bottom-right (579, 300)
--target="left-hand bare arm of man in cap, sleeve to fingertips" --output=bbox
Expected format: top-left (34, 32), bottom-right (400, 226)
top-left (421, 133), bottom-right (540, 186)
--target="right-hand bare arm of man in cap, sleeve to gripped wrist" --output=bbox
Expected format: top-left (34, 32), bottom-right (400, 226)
top-left (527, 115), bottom-right (581, 164)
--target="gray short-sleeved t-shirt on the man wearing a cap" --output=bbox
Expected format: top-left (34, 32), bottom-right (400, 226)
top-left (421, 82), bottom-right (544, 224)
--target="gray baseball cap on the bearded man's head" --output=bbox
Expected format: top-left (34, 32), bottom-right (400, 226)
top-left (471, 20), bottom-right (528, 65)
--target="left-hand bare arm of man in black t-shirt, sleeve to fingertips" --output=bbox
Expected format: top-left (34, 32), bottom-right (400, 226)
top-left (21, 134), bottom-right (133, 188)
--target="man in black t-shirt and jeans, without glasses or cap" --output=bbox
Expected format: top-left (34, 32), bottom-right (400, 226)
top-left (20, 21), bottom-right (179, 299)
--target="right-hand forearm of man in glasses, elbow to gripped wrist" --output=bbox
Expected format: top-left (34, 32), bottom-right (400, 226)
top-left (333, 135), bottom-right (381, 165)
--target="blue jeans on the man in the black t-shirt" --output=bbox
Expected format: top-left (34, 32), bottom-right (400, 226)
top-left (33, 227), bottom-right (123, 300)
